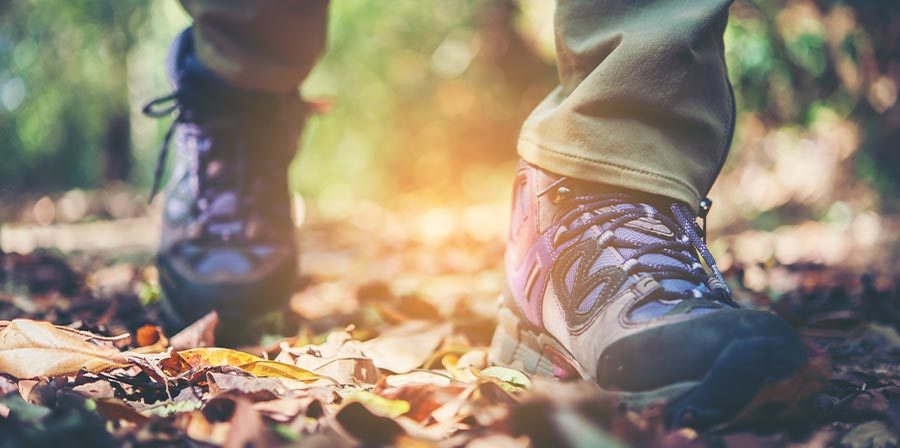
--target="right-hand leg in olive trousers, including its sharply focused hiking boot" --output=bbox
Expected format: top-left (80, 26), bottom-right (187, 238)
top-left (491, 0), bottom-right (815, 429)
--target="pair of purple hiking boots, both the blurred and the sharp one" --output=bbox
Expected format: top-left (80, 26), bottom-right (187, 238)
top-left (145, 29), bottom-right (809, 428)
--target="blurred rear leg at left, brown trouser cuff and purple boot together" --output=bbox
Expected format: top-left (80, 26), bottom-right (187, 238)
top-left (145, 0), bottom-right (327, 343)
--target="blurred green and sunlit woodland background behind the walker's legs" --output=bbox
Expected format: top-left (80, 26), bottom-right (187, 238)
top-left (0, 0), bottom-right (900, 290)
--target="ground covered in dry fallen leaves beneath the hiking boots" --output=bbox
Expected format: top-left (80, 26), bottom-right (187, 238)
top-left (0, 217), bottom-right (900, 448)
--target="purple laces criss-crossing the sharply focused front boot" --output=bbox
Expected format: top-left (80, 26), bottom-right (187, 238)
top-left (548, 189), bottom-right (734, 305)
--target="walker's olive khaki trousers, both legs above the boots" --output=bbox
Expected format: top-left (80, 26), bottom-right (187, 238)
top-left (181, 0), bottom-right (734, 208)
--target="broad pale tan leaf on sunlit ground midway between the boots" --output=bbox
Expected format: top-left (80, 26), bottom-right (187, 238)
top-left (362, 321), bottom-right (451, 373)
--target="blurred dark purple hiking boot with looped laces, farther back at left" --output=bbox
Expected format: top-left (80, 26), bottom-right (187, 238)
top-left (144, 29), bottom-right (307, 332)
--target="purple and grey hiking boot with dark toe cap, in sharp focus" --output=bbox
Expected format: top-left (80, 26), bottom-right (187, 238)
top-left (491, 163), bottom-right (815, 429)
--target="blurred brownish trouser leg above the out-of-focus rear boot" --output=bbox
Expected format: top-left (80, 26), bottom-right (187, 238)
top-left (180, 0), bottom-right (328, 92)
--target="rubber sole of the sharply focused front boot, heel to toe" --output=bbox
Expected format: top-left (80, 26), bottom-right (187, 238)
top-left (489, 307), bottom-right (827, 430)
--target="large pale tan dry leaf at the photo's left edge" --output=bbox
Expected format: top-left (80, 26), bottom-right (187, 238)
top-left (0, 319), bottom-right (130, 378)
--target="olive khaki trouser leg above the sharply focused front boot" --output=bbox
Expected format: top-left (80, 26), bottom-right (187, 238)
top-left (518, 0), bottom-right (734, 208)
